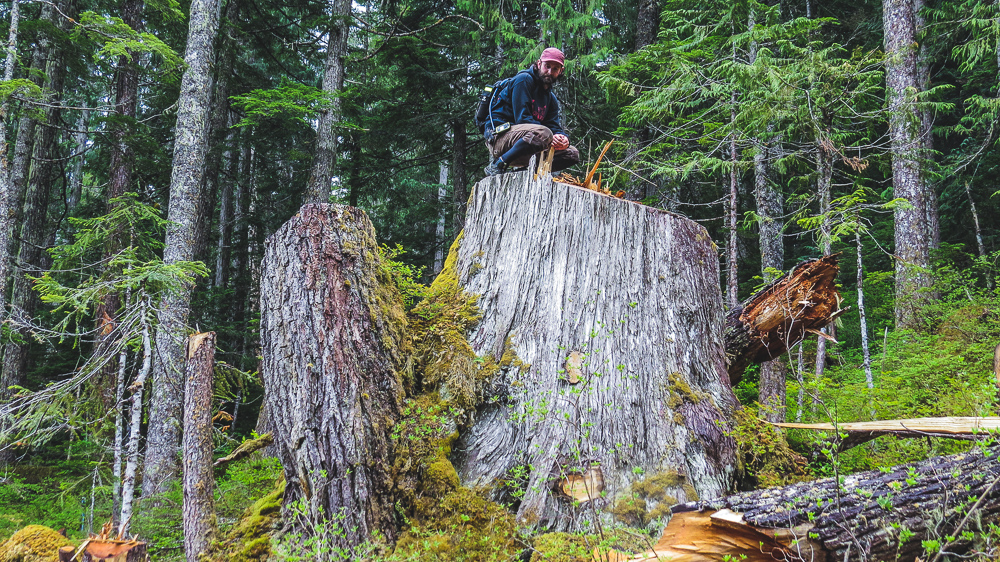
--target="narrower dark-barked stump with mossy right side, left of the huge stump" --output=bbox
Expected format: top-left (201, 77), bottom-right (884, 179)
top-left (261, 204), bottom-right (410, 546)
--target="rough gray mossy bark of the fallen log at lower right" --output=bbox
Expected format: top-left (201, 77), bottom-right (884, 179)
top-left (674, 448), bottom-right (1000, 562)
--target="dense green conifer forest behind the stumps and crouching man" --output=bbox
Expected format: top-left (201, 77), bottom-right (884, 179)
top-left (0, 0), bottom-right (1000, 556)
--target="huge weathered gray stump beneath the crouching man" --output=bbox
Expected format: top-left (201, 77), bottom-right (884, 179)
top-left (450, 167), bottom-right (737, 529)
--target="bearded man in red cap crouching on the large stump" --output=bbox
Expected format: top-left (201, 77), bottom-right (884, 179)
top-left (485, 48), bottom-right (580, 176)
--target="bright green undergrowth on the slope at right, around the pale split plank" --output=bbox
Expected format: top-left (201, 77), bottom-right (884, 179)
top-left (786, 260), bottom-right (1000, 475)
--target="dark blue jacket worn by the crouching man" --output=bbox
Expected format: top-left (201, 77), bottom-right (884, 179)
top-left (487, 65), bottom-right (566, 135)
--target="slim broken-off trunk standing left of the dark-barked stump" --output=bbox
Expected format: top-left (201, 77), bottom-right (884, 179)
top-left (183, 332), bottom-right (216, 562)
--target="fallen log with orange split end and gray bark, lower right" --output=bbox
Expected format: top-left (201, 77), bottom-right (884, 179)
top-left (612, 447), bottom-right (1000, 562)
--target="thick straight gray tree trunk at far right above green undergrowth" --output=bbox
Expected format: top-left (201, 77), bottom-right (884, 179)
top-left (882, 0), bottom-right (931, 328)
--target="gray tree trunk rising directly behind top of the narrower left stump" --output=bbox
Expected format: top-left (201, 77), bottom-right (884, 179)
top-left (305, 0), bottom-right (351, 203)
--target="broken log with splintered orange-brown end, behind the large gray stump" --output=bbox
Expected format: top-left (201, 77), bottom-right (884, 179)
top-left (724, 254), bottom-right (847, 386)
